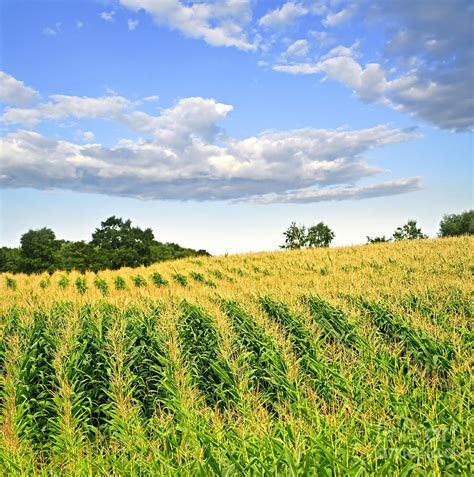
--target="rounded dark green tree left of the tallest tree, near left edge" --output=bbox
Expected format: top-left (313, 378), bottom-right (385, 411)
top-left (20, 227), bottom-right (60, 273)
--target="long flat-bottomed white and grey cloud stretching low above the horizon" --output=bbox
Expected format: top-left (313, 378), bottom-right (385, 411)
top-left (0, 71), bottom-right (419, 203)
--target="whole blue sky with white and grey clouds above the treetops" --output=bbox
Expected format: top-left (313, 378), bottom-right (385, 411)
top-left (0, 0), bottom-right (474, 254)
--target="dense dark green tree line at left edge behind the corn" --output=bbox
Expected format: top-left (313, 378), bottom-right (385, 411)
top-left (0, 216), bottom-right (209, 273)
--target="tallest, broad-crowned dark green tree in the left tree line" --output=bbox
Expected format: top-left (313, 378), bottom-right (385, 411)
top-left (90, 216), bottom-right (154, 269)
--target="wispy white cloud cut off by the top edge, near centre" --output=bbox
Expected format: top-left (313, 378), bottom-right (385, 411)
top-left (120, 0), bottom-right (256, 51)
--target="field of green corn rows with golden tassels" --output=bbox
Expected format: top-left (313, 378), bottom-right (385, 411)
top-left (0, 237), bottom-right (474, 476)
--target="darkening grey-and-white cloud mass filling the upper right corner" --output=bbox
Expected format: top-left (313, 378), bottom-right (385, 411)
top-left (273, 0), bottom-right (474, 131)
